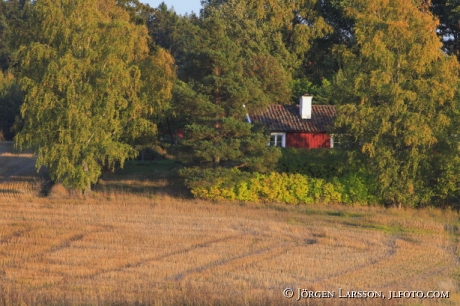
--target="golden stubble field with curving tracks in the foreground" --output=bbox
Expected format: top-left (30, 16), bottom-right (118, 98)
top-left (0, 143), bottom-right (460, 305)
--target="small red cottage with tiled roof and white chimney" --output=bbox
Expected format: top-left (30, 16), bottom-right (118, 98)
top-left (250, 95), bottom-right (335, 149)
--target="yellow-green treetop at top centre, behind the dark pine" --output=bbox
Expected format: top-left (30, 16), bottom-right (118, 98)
top-left (202, 0), bottom-right (332, 77)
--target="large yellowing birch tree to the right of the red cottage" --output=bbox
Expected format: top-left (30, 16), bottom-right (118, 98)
top-left (333, 0), bottom-right (459, 205)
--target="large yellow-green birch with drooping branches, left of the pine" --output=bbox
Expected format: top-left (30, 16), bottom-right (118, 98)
top-left (16, 0), bottom-right (174, 190)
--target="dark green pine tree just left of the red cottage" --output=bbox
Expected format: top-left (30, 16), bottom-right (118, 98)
top-left (174, 11), bottom-right (290, 172)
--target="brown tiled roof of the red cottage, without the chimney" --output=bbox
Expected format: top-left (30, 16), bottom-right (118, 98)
top-left (250, 105), bottom-right (335, 133)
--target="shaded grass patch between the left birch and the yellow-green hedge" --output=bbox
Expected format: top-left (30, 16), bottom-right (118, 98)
top-left (94, 159), bottom-right (191, 198)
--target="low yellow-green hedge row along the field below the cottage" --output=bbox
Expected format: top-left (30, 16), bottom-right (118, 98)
top-left (181, 168), bottom-right (375, 205)
